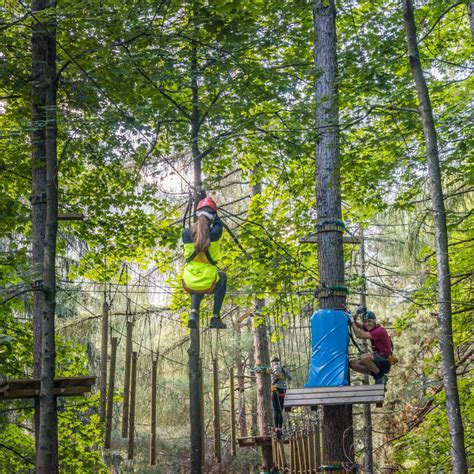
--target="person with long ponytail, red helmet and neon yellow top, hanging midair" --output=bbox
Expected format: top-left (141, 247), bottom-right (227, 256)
top-left (182, 197), bottom-right (227, 329)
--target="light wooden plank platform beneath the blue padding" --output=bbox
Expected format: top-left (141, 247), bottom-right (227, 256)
top-left (285, 385), bottom-right (385, 411)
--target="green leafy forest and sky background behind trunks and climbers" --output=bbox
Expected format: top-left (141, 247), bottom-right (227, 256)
top-left (0, 0), bottom-right (474, 472)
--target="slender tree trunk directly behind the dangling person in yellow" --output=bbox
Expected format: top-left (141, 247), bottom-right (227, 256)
top-left (188, 0), bottom-right (203, 474)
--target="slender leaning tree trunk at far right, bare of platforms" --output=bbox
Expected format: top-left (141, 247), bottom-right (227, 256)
top-left (403, 0), bottom-right (467, 473)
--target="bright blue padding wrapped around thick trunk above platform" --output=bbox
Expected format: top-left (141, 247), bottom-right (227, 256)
top-left (305, 309), bottom-right (349, 387)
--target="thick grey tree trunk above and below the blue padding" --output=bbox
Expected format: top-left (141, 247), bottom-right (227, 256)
top-left (314, 0), bottom-right (353, 461)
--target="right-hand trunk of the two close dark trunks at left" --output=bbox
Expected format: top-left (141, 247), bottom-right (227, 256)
top-left (36, 0), bottom-right (58, 474)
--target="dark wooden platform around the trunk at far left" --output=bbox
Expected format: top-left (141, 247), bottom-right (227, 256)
top-left (0, 376), bottom-right (95, 400)
